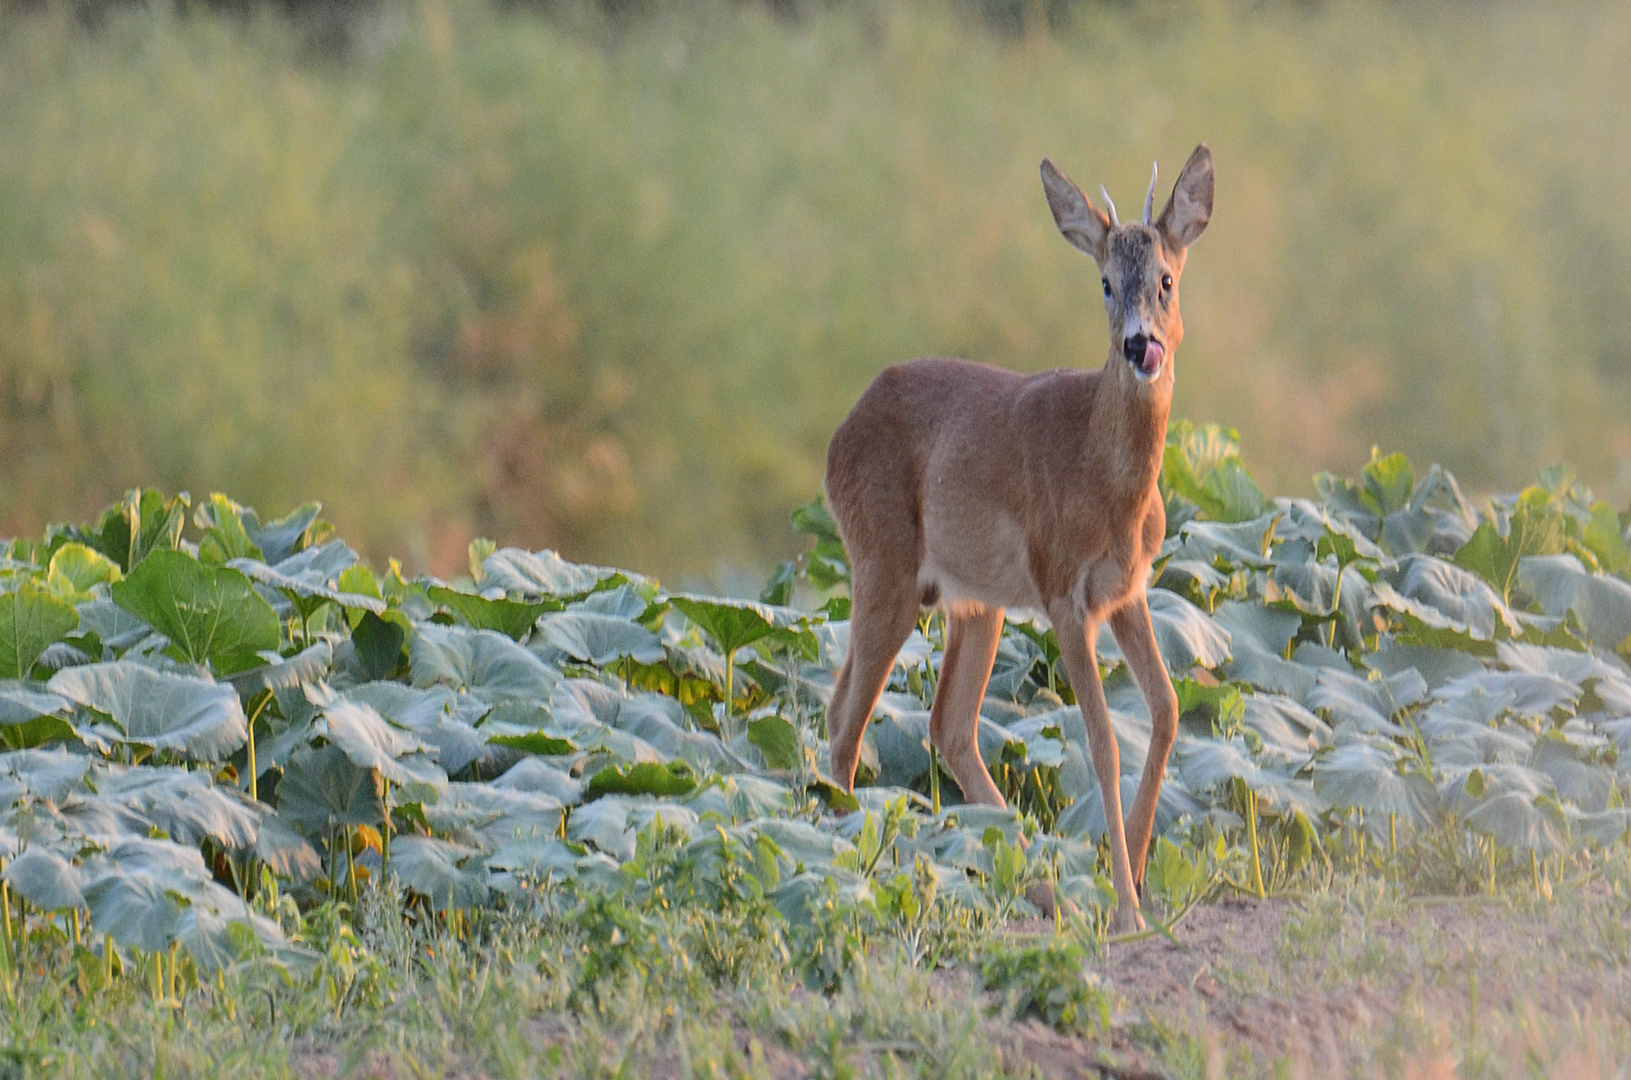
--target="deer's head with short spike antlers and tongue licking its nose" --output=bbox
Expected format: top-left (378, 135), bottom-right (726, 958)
top-left (1042, 144), bottom-right (1212, 387)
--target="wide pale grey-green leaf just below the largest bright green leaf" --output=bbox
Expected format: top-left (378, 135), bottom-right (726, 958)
top-left (47, 659), bottom-right (250, 762)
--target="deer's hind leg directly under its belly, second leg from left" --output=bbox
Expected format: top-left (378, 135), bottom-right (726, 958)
top-left (928, 607), bottom-right (1008, 806)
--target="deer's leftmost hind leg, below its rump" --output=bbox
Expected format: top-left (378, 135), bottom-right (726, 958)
top-left (827, 568), bottom-right (918, 791)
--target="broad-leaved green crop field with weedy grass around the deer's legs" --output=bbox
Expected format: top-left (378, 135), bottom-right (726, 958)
top-left (0, 423), bottom-right (1631, 1075)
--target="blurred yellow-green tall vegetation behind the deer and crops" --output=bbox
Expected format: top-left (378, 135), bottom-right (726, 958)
top-left (0, 0), bottom-right (1631, 584)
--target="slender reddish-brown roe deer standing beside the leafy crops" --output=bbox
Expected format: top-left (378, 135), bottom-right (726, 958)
top-left (827, 144), bottom-right (1212, 933)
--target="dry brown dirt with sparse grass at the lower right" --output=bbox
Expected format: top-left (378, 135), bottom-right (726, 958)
top-left (295, 896), bottom-right (1631, 1080)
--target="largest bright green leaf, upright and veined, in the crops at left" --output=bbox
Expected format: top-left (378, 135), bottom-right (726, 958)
top-left (113, 550), bottom-right (279, 674)
